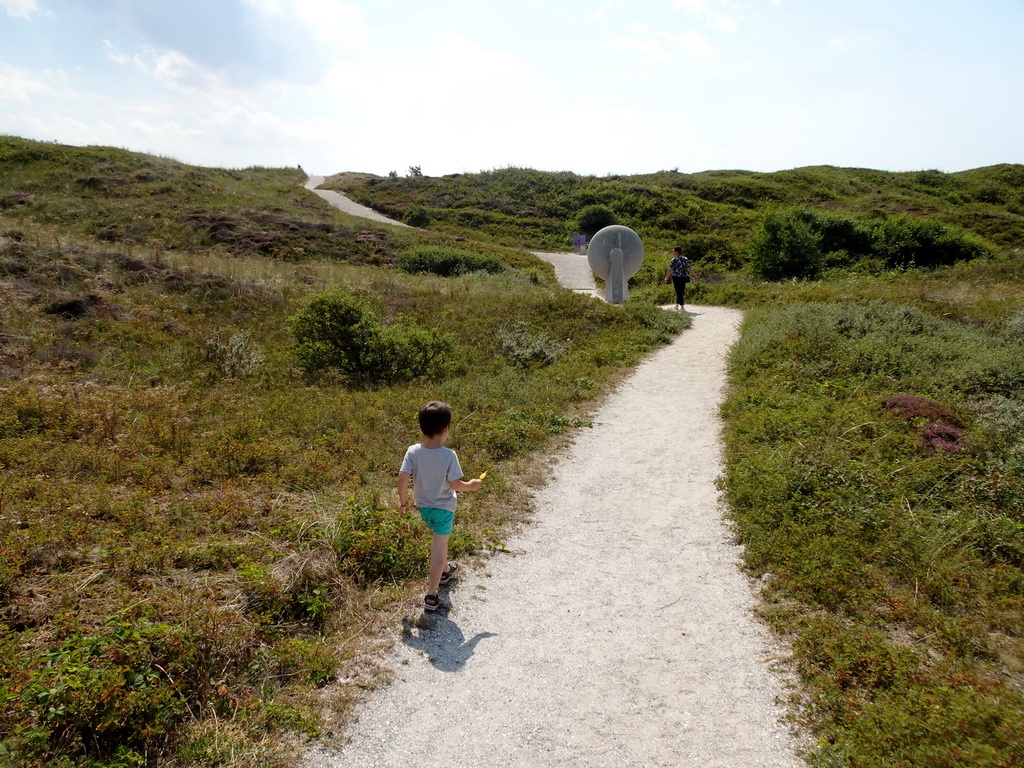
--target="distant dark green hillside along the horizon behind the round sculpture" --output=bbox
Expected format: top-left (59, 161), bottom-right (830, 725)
top-left (328, 165), bottom-right (1024, 267)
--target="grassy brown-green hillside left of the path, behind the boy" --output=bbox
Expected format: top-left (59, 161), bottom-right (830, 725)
top-left (0, 137), bottom-right (682, 766)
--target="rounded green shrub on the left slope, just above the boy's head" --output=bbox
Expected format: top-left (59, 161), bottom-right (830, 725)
top-left (289, 292), bottom-right (455, 384)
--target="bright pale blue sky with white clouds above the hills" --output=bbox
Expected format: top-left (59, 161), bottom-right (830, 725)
top-left (0, 0), bottom-right (1024, 176)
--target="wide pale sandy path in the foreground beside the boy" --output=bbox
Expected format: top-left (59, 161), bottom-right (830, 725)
top-left (305, 307), bottom-right (802, 768)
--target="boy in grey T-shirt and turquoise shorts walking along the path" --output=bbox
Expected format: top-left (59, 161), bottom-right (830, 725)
top-left (398, 400), bottom-right (483, 610)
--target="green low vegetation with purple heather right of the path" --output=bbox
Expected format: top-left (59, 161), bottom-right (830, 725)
top-left (723, 290), bottom-right (1024, 766)
